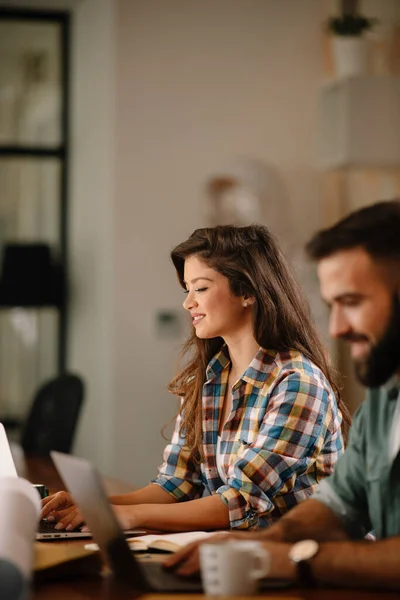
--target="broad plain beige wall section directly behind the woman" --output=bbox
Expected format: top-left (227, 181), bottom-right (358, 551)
top-left (113, 0), bottom-right (324, 484)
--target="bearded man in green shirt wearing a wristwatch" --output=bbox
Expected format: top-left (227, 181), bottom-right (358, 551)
top-left (166, 200), bottom-right (400, 588)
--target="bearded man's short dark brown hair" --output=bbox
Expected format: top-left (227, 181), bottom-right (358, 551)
top-left (306, 199), bottom-right (400, 260)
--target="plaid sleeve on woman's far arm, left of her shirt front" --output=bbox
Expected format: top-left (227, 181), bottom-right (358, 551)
top-left (152, 413), bottom-right (204, 501)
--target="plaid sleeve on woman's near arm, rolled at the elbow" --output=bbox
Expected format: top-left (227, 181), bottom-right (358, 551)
top-left (217, 371), bottom-right (342, 529)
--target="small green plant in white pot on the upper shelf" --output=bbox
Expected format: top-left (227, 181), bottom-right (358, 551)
top-left (327, 14), bottom-right (377, 77)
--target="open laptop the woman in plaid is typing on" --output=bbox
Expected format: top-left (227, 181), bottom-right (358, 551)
top-left (0, 423), bottom-right (146, 542)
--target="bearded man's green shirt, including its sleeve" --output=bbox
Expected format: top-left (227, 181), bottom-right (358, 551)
top-left (314, 379), bottom-right (400, 539)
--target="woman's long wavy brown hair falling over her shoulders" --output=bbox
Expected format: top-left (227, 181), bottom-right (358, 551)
top-left (168, 225), bottom-right (351, 462)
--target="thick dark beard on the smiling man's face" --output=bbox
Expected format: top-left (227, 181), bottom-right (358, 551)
top-left (354, 295), bottom-right (400, 387)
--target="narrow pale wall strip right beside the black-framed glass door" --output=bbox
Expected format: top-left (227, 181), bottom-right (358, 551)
top-left (68, 0), bottom-right (116, 472)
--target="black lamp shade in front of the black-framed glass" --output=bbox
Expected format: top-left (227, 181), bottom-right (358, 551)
top-left (0, 243), bottom-right (64, 307)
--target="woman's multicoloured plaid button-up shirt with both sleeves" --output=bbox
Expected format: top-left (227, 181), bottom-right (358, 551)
top-left (154, 346), bottom-right (343, 529)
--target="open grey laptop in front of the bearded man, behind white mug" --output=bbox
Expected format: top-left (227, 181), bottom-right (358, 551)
top-left (50, 451), bottom-right (290, 593)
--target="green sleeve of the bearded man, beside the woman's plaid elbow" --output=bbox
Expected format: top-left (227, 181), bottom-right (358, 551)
top-left (314, 402), bottom-right (372, 539)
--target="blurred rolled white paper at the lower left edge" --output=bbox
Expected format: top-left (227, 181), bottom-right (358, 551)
top-left (0, 477), bottom-right (41, 580)
